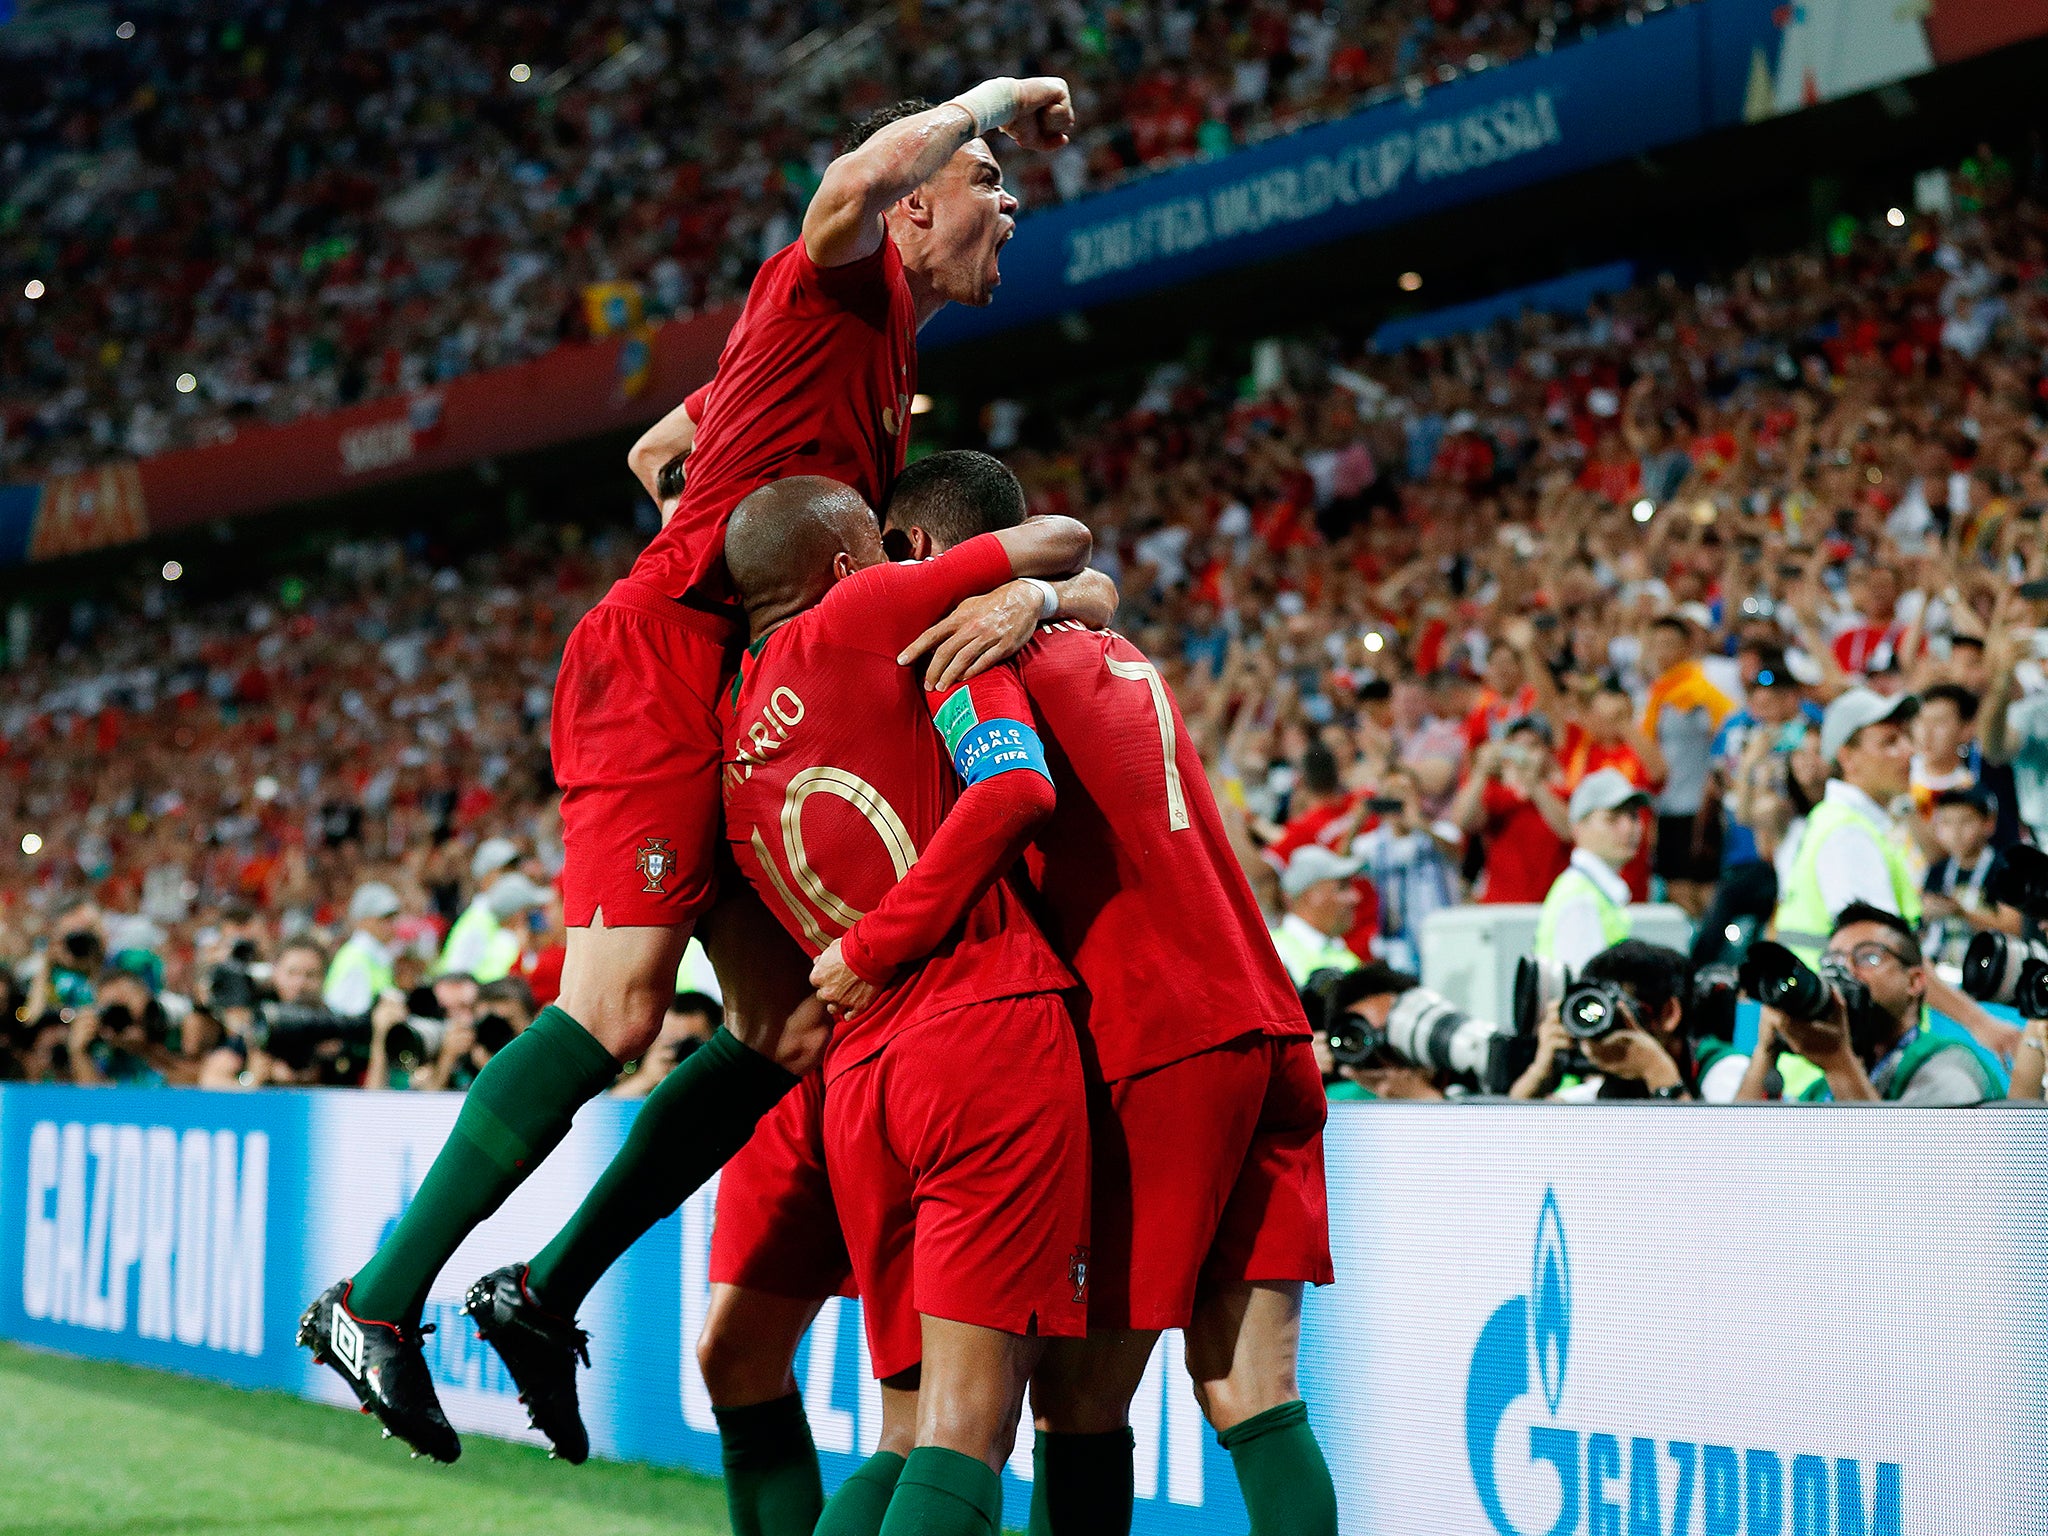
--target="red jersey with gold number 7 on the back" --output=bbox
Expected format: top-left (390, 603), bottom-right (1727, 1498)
top-left (1018, 623), bottom-right (1309, 1081)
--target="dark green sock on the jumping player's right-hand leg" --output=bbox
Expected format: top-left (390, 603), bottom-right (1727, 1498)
top-left (528, 1028), bottom-right (797, 1317)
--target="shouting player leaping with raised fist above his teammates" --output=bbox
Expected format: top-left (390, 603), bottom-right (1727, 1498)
top-left (299, 80), bottom-right (1073, 1460)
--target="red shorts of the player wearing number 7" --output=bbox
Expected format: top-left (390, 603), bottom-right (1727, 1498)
top-left (1087, 1034), bottom-right (1335, 1329)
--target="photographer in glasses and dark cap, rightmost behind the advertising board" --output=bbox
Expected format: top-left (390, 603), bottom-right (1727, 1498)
top-left (1737, 901), bottom-right (1999, 1108)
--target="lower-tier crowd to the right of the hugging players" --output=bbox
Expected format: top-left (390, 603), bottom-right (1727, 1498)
top-left (1007, 150), bottom-right (2048, 1102)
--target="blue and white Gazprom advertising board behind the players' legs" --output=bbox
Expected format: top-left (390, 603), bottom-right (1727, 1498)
top-left (0, 1087), bottom-right (2048, 1536)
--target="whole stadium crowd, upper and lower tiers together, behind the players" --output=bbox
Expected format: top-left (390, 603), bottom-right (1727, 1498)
top-left (0, 0), bottom-right (2048, 1098)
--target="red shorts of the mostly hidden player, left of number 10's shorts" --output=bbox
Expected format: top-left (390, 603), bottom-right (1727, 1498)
top-left (711, 1071), bottom-right (854, 1300)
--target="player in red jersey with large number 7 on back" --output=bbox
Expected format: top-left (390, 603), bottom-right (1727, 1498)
top-left (884, 453), bottom-right (1337, 1536)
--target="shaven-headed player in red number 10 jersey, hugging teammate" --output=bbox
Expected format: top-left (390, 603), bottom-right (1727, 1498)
top-left (725, 477), bottom-right (1087, 1536)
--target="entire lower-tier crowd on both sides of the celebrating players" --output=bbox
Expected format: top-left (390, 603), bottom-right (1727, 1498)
top-left (0, 152), bottom-right (2048, 1098)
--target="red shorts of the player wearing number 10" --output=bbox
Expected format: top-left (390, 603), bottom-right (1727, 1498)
top-left (825, 993), bottom-right (1090, 1378)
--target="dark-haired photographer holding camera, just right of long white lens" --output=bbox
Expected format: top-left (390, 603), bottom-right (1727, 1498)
top-left (1507, 938), bottom-right (1741, 1102)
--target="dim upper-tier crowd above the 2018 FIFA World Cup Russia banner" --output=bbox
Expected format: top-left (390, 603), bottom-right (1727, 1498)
top-left (0, 0), bottom-right (1665, 479)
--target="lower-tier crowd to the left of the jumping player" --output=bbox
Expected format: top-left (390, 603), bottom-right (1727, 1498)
top-left (0, 530), bottom-right (717, 1092)
